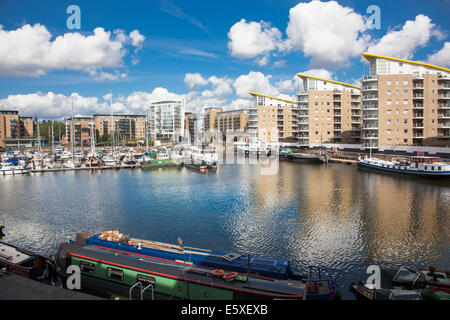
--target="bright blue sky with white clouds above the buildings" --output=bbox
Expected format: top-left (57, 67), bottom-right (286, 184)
top-left (0, 0), bottom-right (450, 118)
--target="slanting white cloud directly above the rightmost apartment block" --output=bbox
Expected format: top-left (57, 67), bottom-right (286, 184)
top-left (367, 14), bottom-right (443, 59)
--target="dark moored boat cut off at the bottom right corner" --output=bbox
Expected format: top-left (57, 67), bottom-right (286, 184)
top-left (349, 265), bottom-right (450, 300)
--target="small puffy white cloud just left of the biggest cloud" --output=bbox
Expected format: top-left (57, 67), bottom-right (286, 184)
top-left (228, 19), bottom-right (281, 60)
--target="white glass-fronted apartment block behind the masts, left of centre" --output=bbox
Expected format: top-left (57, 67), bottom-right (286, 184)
top-left (148, 100), bottom-right (185, 141)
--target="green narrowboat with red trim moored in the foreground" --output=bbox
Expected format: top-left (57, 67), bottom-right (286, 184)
top-left (71, 248), bottom-right (318, 300)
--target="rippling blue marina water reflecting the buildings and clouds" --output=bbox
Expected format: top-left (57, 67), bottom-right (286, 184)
top-left (0, 162), bottom-right (450, 299)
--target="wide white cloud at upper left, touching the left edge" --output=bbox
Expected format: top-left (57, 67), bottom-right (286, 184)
top-left (0, 24), bottom-right (144, 80)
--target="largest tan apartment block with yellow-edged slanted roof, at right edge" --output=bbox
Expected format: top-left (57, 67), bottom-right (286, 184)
top-left (362, 53), bottom-right (450, 149)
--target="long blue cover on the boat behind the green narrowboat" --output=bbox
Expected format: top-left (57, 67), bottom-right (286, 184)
top-left (87, 234), bottom-right (292, 279)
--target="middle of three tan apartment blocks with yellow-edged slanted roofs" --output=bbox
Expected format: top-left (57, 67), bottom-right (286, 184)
top-left (297, 73), bottom-right (361, 147)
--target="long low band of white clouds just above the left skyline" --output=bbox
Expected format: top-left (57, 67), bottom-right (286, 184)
top-left (0, 71), bottom-right (302, 119)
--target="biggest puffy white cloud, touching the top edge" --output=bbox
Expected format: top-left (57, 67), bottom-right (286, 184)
top-left (286, 1), bottom-right (369, 68)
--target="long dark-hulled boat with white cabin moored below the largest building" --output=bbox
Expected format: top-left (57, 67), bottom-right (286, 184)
top-left (357, 156), bottom-right (450, 179)
